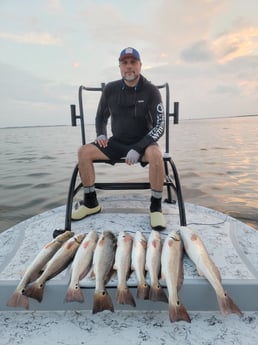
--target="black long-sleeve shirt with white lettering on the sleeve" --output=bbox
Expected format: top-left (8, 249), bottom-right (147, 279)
top-left (95, 75), bottom-right (165, 153)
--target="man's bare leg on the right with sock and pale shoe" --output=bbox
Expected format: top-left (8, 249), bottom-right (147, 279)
top-left (142, 145), bottom-right (166, 230)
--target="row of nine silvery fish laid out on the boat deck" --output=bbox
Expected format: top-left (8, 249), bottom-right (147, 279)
top-left (7, 227), bottom-right (243, 322)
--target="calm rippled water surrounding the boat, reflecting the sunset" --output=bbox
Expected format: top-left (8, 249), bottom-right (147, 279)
top-left (0, 116), bottom-right (258, 232)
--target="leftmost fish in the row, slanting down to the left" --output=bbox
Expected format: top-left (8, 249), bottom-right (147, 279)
top-left (7, 231), bottom-right (74, 309)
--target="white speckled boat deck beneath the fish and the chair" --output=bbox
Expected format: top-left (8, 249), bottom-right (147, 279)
top-left (0, 194), bottom-right (258, 345)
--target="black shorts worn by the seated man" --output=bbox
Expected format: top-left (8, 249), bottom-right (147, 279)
top-left (92, 137), bottom-right (157, 166)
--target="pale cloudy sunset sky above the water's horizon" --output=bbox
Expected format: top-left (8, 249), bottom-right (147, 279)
top-left (0, 0), bottom-right (258, 127)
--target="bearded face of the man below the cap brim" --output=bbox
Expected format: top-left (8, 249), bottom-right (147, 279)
top-left (119, 57), bottom-right (142, 84)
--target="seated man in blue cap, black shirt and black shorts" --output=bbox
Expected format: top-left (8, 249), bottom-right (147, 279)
top-left (72, 47), bottom-right (166, 230)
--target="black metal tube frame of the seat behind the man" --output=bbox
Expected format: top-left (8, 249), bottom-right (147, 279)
top-left (61, 83), bottom-right (186, 234)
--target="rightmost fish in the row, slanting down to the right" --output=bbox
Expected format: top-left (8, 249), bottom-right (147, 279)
top-left (180, 226), bottom-right (243, 316)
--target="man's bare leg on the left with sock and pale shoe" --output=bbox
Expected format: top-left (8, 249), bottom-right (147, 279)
top-left (72, 144), bottom-right (108, 220)
